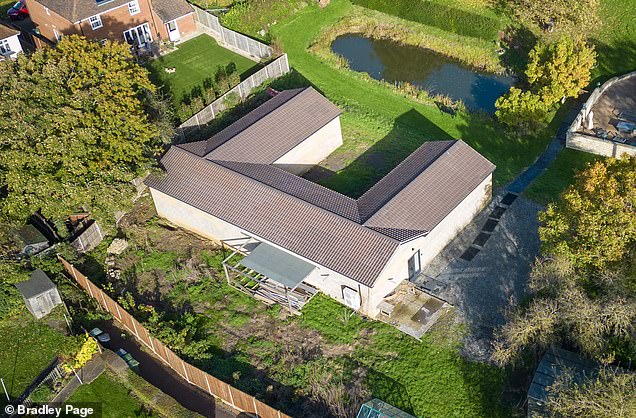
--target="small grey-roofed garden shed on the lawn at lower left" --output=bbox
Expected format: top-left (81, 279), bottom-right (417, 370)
top-left (15, 269), bottom-right (62, 319)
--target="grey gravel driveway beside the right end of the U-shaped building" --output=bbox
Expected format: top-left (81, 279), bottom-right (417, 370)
top-left (414, 196), bottom-right (542, 360)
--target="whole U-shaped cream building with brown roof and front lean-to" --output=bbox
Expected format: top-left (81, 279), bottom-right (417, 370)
top-left (146, 87), bottom-right (495, 316)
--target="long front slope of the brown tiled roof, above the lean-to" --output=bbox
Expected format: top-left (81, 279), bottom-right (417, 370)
top-left (146, 147), bottom-right (399, 286)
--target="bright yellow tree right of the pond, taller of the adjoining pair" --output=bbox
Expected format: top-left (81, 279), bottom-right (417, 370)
top-left (526, 37), bottom-right (596, 106)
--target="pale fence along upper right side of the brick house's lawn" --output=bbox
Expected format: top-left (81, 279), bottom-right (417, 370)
top-left (192, 5), bottom-right (274, 60)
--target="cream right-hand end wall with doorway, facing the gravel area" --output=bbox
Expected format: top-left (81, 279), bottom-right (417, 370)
top-left (368, 174), bottom-right (492, 317)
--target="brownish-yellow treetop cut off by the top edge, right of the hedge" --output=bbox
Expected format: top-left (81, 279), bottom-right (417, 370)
top-left (508, 0), bottom-right (599, 34)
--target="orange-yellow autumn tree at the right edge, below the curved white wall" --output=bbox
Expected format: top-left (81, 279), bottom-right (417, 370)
top-left (539, 157), bottom-right (636, 270)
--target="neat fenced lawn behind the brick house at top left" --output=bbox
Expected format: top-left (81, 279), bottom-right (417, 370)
top-left (148, 34), bottom-right (259, 104)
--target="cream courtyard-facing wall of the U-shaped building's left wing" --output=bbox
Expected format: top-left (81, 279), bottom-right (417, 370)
top-left (274, 117), bottom-right (342, 175)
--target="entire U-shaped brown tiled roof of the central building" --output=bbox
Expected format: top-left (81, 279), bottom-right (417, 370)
top-left (146, 88), bottom-right (495, 286)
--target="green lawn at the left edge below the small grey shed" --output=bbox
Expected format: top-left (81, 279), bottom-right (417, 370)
top-left (0, 307), bottom-right (76, 405)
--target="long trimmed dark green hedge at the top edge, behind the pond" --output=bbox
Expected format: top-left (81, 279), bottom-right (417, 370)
top-left (353, 0), bottom-right (504, 40)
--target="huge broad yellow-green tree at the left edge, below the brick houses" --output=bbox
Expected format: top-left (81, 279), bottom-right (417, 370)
top-left (0, 36), bottom-right (171, 227)
